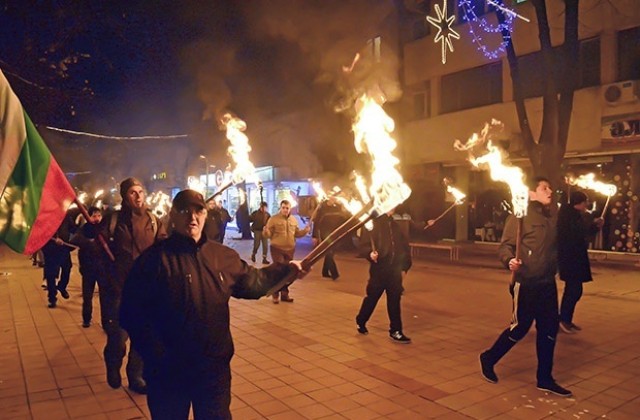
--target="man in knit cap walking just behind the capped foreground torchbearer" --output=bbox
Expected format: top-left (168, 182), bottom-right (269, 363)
top-left (102, 178), bottom-right (167, 394)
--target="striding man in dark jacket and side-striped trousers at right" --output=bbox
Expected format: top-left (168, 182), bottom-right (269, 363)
top-left (480, 178), bottom-right (572, 397)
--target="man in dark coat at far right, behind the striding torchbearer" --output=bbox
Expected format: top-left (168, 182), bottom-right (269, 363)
top-left (558, 191), bottom-right (604, 334)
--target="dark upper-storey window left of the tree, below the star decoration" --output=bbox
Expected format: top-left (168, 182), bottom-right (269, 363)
top-left (441, 62), bottom-right (502, 114)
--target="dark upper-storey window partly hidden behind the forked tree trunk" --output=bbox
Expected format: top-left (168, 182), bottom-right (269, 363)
top-left (518, 38), bottom-right (600, 98)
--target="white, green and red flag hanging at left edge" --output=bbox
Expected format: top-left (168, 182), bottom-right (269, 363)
top-left (0, 71), bottom-right (76, 254)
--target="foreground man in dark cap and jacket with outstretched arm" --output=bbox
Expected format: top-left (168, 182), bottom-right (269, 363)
top-left (120, 190), bottom-right (303, 419)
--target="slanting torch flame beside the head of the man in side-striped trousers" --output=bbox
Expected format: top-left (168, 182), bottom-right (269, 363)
top-left (469, 141), bottom-right (529, 217)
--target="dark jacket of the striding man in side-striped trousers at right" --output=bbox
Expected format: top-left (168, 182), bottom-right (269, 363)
top-left (498, 201), bottom-right (557, 283)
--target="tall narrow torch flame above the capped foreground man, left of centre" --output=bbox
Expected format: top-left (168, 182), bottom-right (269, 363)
top-left (222, 114), bottom-right (258, 184)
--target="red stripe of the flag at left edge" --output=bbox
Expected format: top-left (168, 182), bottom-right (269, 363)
top-left (24, 156), bottom-right (76, 254)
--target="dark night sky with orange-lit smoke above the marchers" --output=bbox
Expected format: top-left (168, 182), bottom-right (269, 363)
top-left (0, 0), bottom-right (395, 186)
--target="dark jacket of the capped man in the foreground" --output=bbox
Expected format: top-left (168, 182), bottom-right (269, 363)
top-left (120, 233), bottom-right (291, 378)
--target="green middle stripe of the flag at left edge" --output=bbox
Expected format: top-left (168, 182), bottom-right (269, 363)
top-left (0, 112), bottom-right (51, 252)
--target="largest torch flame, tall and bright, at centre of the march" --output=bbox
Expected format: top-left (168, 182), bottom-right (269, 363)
top-left (353, 94), bottom-right (411, 214)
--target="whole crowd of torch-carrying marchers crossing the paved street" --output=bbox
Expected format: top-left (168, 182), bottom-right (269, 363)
top-left (34, 178), bottom-right (602, 419)
